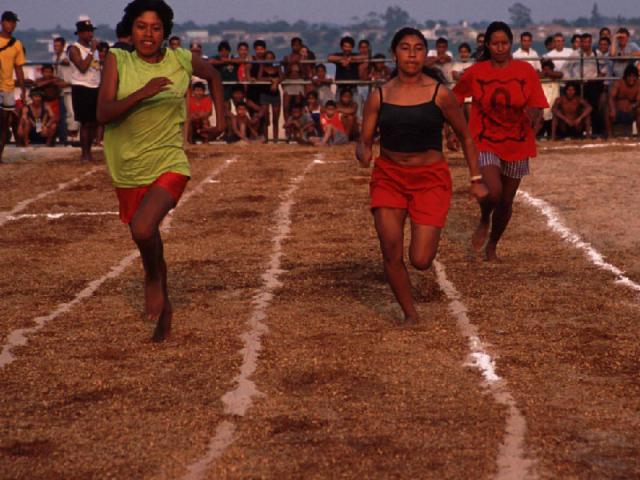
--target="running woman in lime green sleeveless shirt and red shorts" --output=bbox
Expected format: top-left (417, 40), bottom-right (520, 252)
top-left (97, 0), bottom-right (226, 341)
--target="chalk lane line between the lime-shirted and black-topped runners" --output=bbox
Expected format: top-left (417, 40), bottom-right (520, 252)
top-left (183, 154), bottom-right (325, 480)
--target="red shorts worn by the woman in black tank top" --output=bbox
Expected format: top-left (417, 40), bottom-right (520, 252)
top-left (370, 157), bottom-right (452, 228)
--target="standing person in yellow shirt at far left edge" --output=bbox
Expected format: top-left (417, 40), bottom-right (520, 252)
top-left (0, 11), bottom-right (25, 163)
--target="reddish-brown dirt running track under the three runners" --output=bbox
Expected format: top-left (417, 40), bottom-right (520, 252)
top-left (0, 146), bottom-right (640, 480)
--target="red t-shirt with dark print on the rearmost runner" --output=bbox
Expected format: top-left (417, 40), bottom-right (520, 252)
top-left (453, 60), bottom-right (549, 161)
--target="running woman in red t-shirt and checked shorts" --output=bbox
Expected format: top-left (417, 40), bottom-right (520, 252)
top-left (453, 22), bottom-right (549, 260)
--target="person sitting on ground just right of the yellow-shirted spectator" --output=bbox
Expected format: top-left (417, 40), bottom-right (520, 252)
top-left (18, 88), bottom-right (58, 147)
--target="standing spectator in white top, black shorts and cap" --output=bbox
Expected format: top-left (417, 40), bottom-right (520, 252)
top-left (69, 20), bottom-right (100, 162)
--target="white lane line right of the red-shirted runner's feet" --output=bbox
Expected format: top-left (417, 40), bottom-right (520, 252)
top-left (518, 191), bottom-right (640, 292)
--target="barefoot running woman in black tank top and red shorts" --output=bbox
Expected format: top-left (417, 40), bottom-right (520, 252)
top-left (356, 28), bottom-right (488, 324)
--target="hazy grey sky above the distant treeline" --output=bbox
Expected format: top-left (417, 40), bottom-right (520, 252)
top-left (12, 0), bottom-right (640, 28)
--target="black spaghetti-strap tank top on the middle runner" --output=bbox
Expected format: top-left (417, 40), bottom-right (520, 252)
top-left (378, 83), bottom-right (444, 153)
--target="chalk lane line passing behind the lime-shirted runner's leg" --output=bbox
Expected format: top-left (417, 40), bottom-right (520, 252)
top-left (0, 158), bottom-right (236, 369)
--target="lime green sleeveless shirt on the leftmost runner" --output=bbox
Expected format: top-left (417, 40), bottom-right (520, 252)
top-left (104, 48), bottom-right (192, 188)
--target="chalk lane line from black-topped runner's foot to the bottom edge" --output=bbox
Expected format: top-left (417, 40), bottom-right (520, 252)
top-left (434, 260), bottom-right (538, 480)
